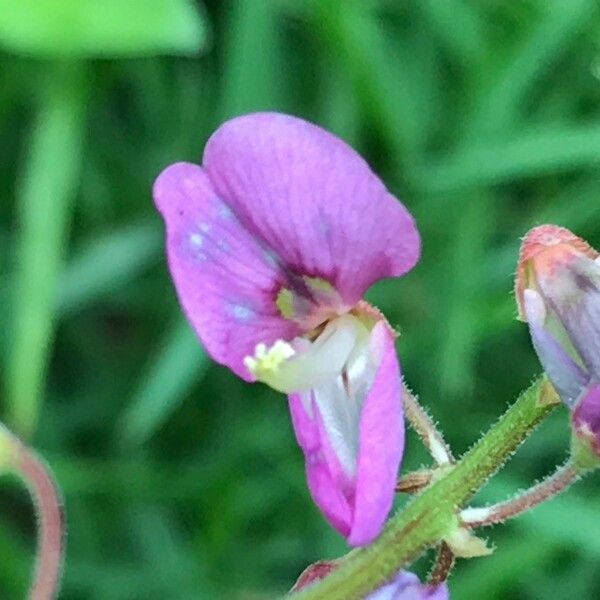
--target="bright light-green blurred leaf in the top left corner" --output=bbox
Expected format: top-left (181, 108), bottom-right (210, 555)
top-left (0, 0), bottom-right (207, 57)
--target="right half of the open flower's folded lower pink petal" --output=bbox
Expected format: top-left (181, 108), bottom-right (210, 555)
top-left (348, 321), bottom-right (404, 546)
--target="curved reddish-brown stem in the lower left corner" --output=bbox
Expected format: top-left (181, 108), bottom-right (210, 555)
top-left (0, 424), bottom-right (64, 600)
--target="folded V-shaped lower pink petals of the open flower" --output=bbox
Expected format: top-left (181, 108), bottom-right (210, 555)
top-left (289, 321), bottom-right (404, 546)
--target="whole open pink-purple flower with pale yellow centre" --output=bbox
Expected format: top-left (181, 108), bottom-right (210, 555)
top-left (154, 113), bottom-right (420, 545)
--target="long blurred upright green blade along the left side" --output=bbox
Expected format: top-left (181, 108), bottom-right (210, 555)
top-left (7, 63), bottom-right (86, 437)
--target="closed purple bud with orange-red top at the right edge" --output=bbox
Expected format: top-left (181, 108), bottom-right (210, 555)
top-left (516, 225), bottom-right (600, 456)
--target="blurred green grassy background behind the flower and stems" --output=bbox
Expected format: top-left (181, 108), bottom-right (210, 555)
top-left (0, 0), bottom-right (600, 600)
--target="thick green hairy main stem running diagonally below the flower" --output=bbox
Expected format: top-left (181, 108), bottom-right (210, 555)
top-left (294, 379), bottom-right (557, 600)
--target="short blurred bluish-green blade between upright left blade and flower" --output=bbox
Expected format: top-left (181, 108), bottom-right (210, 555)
top-left (58, 222), bottom-right (162, 313)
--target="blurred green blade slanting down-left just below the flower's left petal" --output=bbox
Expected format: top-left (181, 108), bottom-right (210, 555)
top-left (121, 318), bottom-right (209, 444)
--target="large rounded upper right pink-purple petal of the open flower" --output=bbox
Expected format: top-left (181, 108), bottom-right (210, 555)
top-left (204, 113), bottom-right (420, 304)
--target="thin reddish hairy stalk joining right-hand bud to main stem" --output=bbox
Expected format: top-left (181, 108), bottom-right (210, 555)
top-left (460, 462), bottom-right (581, 529)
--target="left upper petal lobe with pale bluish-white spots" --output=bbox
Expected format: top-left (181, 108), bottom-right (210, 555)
top-left (154, 163), bottom-right (298, 380)
